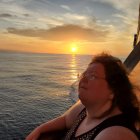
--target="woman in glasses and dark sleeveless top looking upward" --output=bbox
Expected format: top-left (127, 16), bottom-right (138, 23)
top-left (26, 54), bottom-right (140, 140)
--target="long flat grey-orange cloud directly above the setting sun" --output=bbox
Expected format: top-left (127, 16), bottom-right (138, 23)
top-left (7, 25), bottom-right (109, 42)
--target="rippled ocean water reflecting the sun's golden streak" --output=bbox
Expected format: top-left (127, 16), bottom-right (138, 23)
top-left (0, 52), bottom-right (140, 140)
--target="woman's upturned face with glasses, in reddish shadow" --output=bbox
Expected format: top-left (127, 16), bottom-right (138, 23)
top-left (79, 63), bottom-right (113, 106)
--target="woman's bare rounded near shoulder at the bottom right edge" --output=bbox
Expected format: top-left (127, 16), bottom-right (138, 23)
top-left (94, 126), bottom-right (139, 140)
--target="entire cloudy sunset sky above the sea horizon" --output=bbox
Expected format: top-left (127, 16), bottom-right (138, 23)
top-left (0, 0), bottom-right (139, 55)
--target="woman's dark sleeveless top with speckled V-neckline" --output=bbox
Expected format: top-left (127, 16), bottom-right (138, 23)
top-left (65, 109), bottom-right (140, 140)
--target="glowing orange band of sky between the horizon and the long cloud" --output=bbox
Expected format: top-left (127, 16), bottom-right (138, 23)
top-left (0, 29), bottom-right (133, 55)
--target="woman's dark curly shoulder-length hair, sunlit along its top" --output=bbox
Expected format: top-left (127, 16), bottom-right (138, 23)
top-left (90, 53), bottom-right (140, 126)
